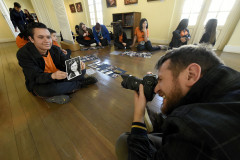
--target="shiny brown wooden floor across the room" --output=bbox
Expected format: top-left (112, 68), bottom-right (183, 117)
top-left (0, 43), bottom-right (240, 160)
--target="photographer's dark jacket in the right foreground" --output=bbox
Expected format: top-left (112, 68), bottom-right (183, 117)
top-left (128, 65), bottom-right (240, 160)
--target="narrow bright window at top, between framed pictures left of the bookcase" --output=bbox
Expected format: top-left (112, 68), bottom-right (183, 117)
top-left (88, 0), bottom-right (103, 25)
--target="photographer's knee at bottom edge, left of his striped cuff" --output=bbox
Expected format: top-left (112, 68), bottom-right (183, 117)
top-left (115, 132), bottom-right (130, 160)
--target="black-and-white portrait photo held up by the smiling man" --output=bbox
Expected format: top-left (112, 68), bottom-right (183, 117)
top-left (65, 56), bottom-right (82, 80)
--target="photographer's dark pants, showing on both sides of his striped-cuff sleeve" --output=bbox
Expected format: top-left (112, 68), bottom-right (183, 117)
top-left (115, 132), bottom-right (162, 160)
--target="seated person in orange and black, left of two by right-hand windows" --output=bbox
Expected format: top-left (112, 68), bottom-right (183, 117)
top-left (169, 19), bottom-right (191, 48)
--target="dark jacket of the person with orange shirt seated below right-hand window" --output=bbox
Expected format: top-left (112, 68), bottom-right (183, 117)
top-left (169, 29), bottom-right (191, 48)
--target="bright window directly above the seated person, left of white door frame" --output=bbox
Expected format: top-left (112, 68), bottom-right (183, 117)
top-left (181, 0), bottom-right (203, 26)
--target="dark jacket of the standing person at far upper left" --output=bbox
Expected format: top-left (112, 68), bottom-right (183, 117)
top-left (10, 8), bottom-right (27, 28)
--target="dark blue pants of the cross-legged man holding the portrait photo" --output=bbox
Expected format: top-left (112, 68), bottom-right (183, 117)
top-left (33, 70), bottom-right (86, 98)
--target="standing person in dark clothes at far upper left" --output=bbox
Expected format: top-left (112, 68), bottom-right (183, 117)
top-left (10, 2), bottom-right (28, 32)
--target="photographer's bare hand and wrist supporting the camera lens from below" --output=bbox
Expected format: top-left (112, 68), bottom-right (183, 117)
top-left (133, 84), bottom-right (147, 123)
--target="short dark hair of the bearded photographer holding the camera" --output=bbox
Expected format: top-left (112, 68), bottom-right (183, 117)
top-left (155, 45), bottom-right (224, 77)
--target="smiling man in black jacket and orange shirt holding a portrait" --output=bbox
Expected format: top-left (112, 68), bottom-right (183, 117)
top-left (17, 22), bottom-right (97, 104)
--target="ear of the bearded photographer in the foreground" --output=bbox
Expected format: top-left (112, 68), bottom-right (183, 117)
top-left (186, 63), bottom-right (201, 87)
